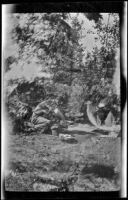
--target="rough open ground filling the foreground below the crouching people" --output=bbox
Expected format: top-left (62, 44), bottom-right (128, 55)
top-left (5, 124), bottom-right (121, 191)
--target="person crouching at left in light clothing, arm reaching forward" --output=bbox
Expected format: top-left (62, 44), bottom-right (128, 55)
top-left (31, 100), bottom-right (66, 133)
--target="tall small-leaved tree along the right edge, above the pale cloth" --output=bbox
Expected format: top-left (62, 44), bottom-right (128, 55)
top-left (84, 14), bottom-right (119, 106)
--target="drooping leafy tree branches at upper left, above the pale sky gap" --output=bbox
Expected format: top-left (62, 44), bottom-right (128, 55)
top-left (12, 13), bottom-right (84, 79)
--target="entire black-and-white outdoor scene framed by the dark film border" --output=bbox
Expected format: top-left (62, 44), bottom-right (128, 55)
top-left (2, 3), bottom-right (125, 199)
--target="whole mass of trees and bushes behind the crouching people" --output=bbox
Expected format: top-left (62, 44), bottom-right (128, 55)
top-left (5, 13), bottom-right (120, 130)
